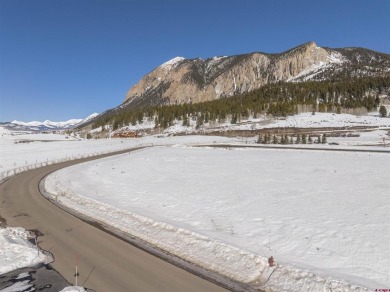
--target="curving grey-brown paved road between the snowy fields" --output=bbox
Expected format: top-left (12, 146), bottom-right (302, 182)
top-left (0, 150), bottom-right (224, 291)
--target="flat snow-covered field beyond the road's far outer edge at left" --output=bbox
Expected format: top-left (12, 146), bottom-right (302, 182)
top-left (0, 127), bottom-right (239, 180)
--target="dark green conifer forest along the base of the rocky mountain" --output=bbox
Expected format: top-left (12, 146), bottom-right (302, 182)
top-left (92, 77), bottom-right (390, 130)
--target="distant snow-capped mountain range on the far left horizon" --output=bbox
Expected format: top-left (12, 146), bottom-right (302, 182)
top-left (0, 113), bottom-right (99, 131)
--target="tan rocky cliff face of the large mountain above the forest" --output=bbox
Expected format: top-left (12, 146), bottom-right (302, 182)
top-left (124, 42), bottom-right (390, 106)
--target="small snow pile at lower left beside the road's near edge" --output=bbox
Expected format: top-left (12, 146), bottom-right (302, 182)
top-left (0, 227), bottom-right (52, 275)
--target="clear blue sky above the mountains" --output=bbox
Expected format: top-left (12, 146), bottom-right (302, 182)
top-left (0, 0), bottom-right (390, 121)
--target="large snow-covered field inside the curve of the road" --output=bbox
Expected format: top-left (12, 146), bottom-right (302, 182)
top-left (46, 147), bottom-right (390, 290)
